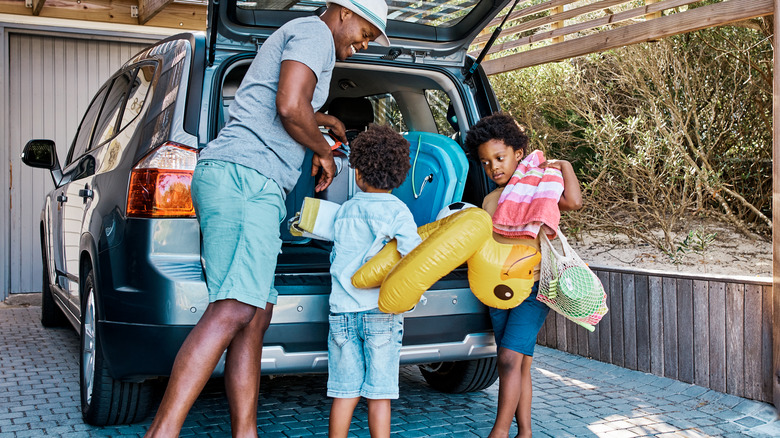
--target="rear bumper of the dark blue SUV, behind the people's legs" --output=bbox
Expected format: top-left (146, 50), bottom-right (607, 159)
top-left (98, 289), bottom-right (496, 381)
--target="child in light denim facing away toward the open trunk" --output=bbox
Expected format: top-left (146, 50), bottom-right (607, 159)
top-left (328, 126), bottom-right (420, 437)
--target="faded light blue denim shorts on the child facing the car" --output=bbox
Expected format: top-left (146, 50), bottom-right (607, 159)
top-left (328, 309), bottom-right (404, 400)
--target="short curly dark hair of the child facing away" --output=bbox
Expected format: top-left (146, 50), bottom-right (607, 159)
top-left (349, 124), bottom-right (412, 190)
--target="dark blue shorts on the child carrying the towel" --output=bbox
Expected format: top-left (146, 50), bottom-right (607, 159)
top-left (490, 281), bottom-right (550, 356)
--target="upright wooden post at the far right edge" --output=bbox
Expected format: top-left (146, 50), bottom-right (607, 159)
top-left (764, 0), bottom-right (780, 410)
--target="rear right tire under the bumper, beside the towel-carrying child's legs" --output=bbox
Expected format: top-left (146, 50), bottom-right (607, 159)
top-left (420, 357), bottom-right (498, 394)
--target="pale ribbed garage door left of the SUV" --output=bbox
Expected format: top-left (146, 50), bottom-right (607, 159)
top-left (5, 33), bottom-right (146, 294)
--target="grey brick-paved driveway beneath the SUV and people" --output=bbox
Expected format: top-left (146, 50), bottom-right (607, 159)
top-left (0, 306), bottom-right (780, 438)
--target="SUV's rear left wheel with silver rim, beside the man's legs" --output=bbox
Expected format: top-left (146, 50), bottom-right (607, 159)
top-left (79, 270), bottom-right (153, 426)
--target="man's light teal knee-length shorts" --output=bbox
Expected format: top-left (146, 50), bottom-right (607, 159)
top-left (192, 160), bottom-right (287, 309)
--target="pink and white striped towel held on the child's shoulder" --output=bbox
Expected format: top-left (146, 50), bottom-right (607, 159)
top-left (493, 150), bottom-right (563, 239)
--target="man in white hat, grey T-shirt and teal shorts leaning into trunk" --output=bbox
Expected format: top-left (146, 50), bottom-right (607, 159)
top-left (146, 0), bottom-right (389, 437)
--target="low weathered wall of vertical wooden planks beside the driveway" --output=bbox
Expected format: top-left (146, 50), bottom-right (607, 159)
top-left (538, 266), bottom-right (772, 403)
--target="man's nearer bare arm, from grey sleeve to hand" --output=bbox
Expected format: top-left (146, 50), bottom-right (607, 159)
top-left (276, 60), bottom-right (336, 192)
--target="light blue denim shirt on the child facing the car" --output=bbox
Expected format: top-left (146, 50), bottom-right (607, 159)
top-left (330, 192), bottom-right (421, 313)
